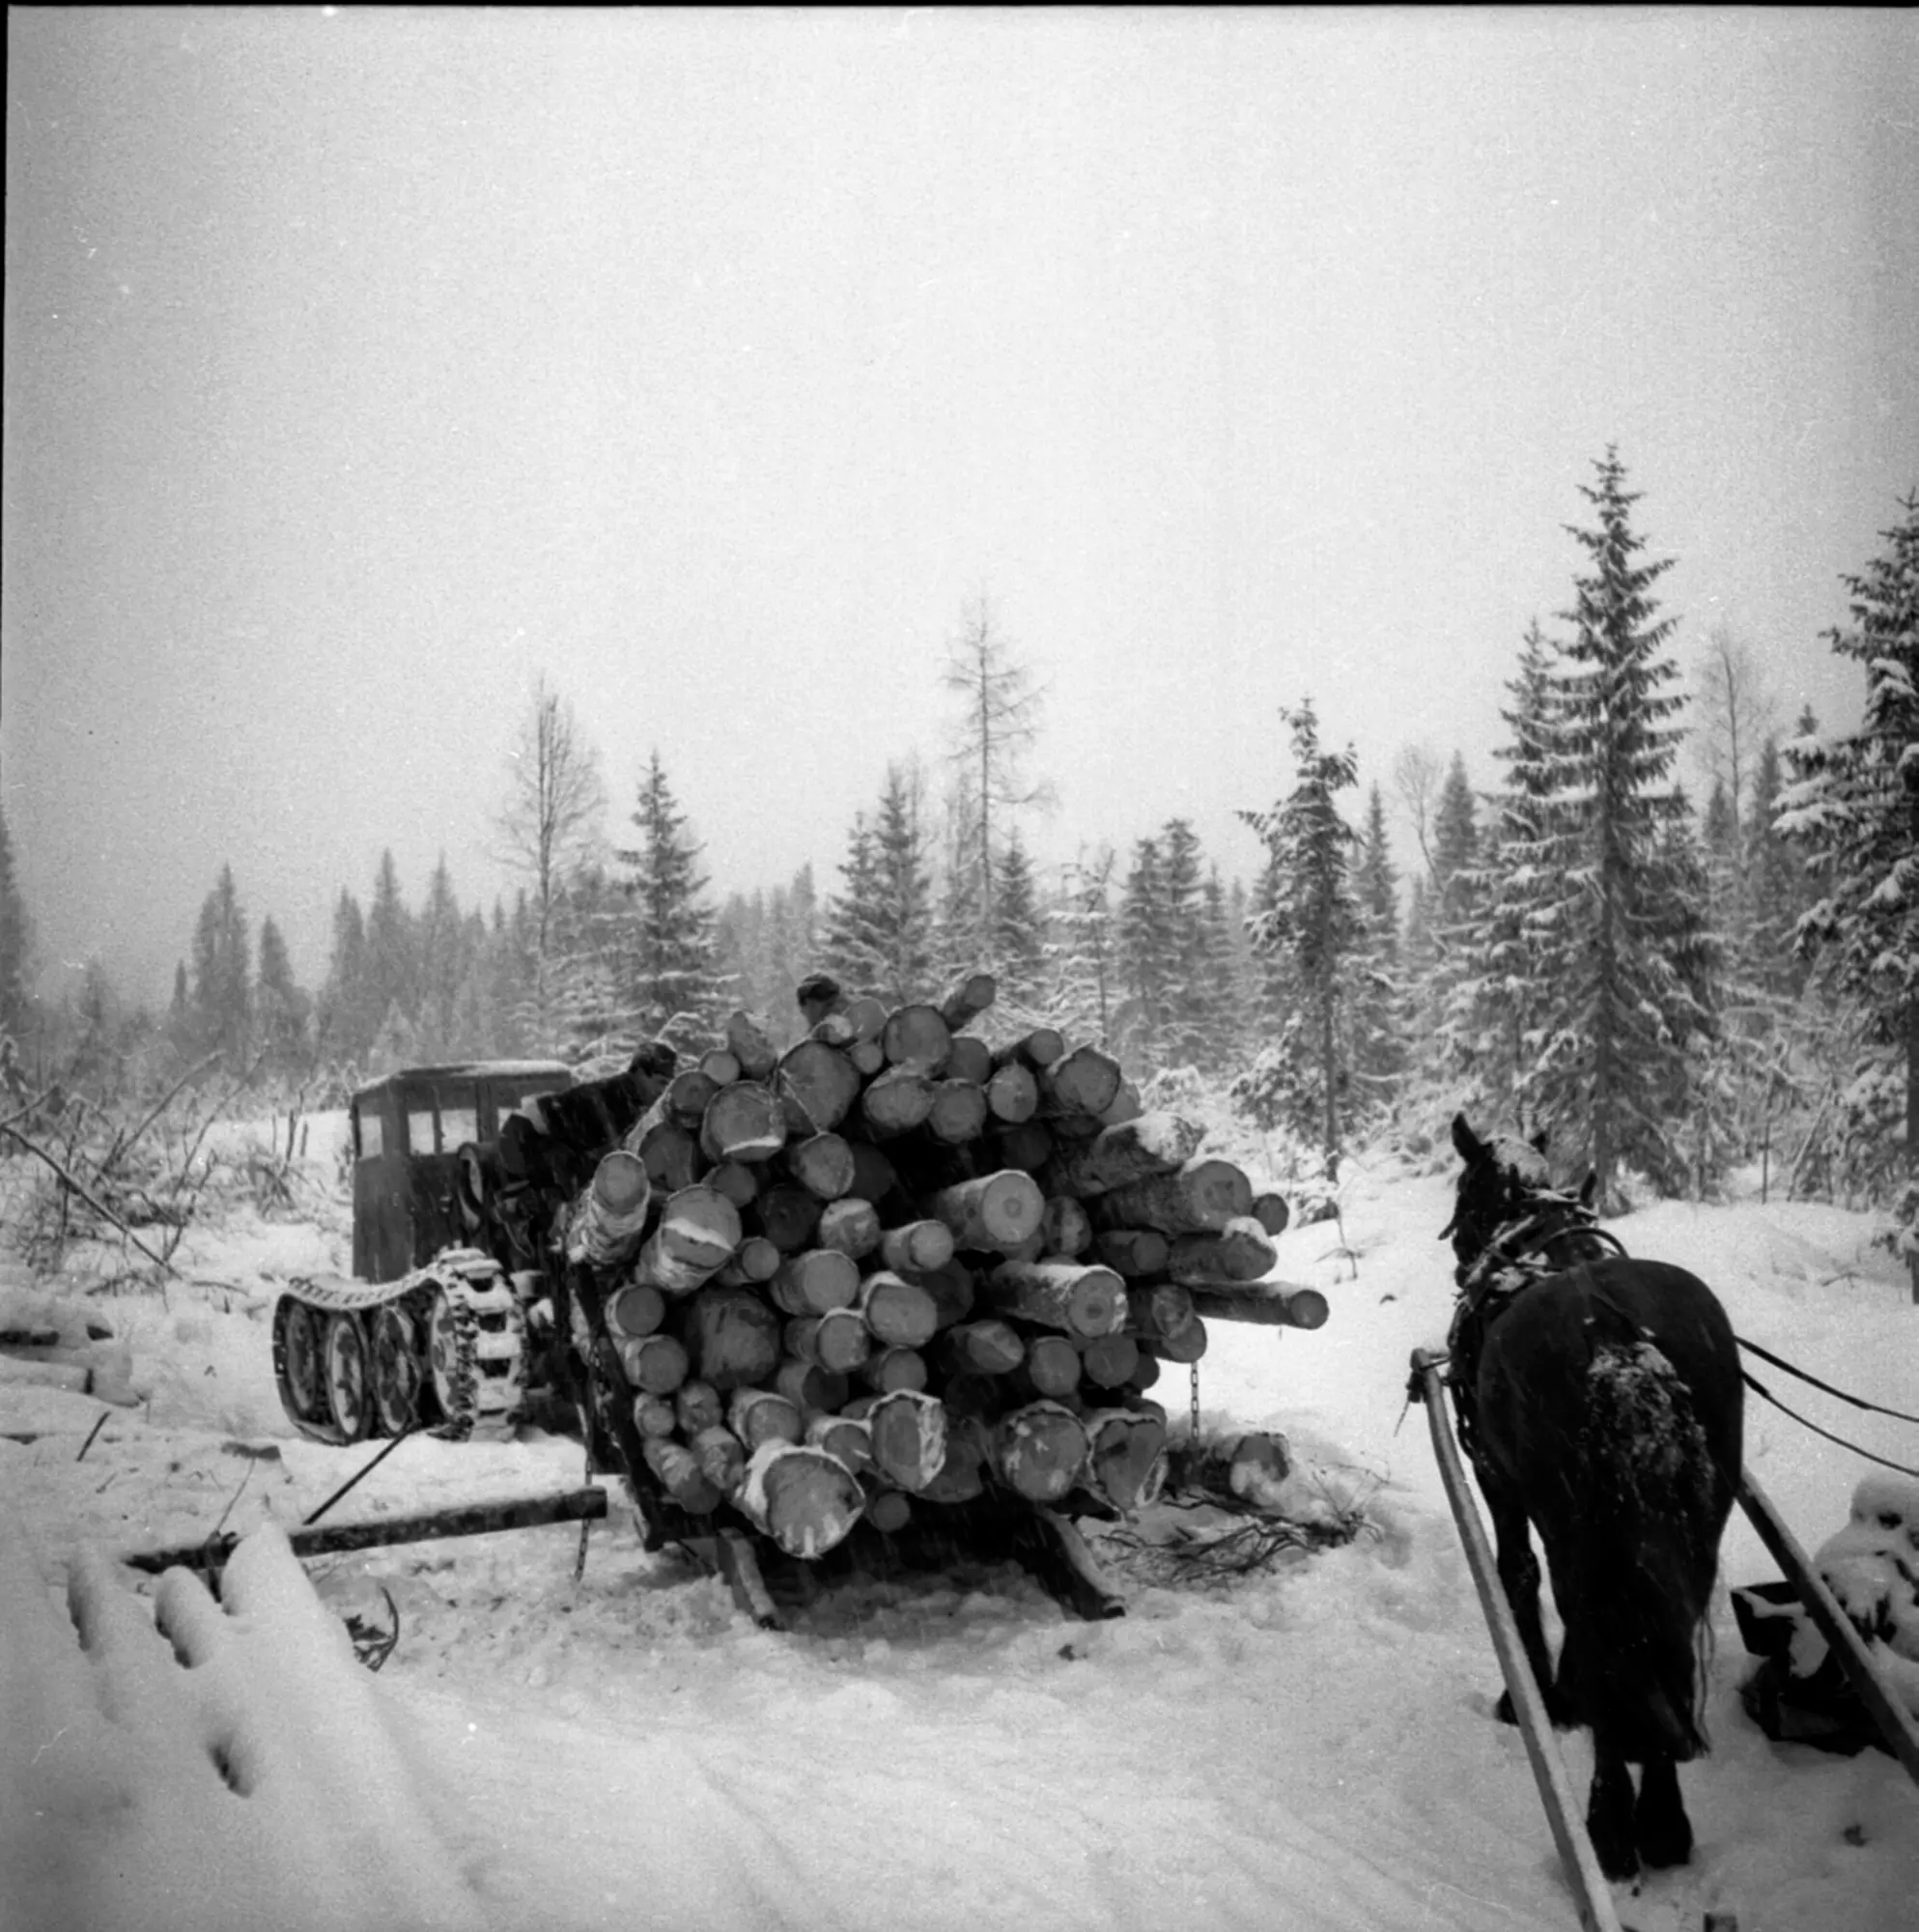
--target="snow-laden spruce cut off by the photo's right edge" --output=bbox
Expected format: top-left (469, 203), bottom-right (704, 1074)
top-left (1776, 491), bottom-right (1919, 1300)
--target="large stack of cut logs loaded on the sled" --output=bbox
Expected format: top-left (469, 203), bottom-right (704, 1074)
top-left (548, 974), bottom-right (1326, 1557)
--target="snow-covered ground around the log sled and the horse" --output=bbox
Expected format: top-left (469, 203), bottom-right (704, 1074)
top-left (0, 1134), bottom-right (1919, 1932)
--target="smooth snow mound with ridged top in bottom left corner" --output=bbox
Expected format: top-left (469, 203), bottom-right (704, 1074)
top-left (0, 1517), bottom-right (489, 1932)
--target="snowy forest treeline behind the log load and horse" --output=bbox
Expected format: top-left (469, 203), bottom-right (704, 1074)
top-left (0, 450), bottom-right (1919, 1225)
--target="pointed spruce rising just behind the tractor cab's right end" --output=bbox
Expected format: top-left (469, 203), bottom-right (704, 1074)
top-left (608, 750), bottom-right (728, 1053)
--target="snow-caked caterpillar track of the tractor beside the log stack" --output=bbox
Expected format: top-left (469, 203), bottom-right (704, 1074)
top-left (272, 1248), bottom-right (541, 1445)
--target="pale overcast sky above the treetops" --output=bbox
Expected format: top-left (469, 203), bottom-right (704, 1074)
top-left (0, 8), bottom-right (1919, 999)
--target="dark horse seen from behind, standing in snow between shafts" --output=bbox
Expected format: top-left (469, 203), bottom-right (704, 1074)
top-left (1440, 1115), bottom-right (1745, 1880)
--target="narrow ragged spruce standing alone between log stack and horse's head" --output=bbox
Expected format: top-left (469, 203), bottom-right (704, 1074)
top-left (1233, 697), bottom-right (1365, 1179)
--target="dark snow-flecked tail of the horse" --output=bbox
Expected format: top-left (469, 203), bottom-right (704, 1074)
top-left (1562, 1339), bottom-right (1718, 1762)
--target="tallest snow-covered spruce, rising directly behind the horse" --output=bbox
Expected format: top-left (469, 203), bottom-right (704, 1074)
top-left (1521, 446), bottom-right (1718, 1208)
